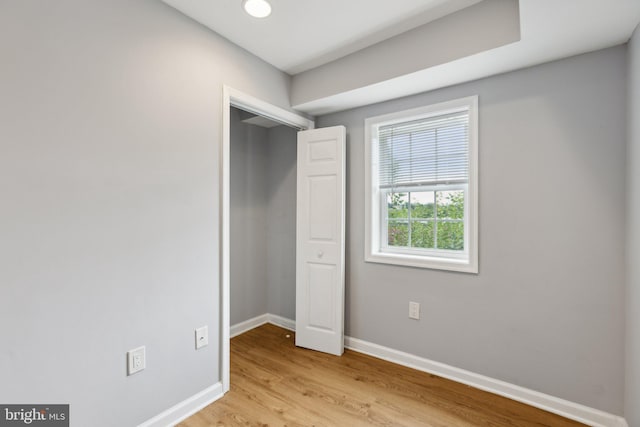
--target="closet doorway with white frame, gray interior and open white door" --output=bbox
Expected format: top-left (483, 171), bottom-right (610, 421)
top-left (219, 86), bottom-right (346, 393)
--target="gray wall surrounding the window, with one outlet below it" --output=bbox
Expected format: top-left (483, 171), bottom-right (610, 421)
top-left (317, 46), bottom-right (626, 414)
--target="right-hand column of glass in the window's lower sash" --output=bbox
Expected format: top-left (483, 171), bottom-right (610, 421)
top-left (436, 190), bottom-right (464, 251)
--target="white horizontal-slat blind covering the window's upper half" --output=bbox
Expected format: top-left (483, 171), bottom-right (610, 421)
top-left (378, 110), bottom-right (469, 188)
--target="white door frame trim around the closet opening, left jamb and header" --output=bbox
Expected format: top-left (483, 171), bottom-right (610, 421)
top-left (218, 85), bottom-right (315, 393)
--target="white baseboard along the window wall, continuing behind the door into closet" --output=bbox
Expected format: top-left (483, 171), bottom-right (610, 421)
top-left (229, 314), bottom-right (629, 427)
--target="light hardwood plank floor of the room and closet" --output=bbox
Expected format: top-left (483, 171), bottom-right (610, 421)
top-left (179, 324), bottom-right (583, 427)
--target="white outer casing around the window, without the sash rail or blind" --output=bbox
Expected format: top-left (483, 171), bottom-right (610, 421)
top-left (364, 95), bottom-right (478, 274)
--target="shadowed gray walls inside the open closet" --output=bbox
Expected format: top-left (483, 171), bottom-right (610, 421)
top-left (230, 109), bottom-right (297, 325)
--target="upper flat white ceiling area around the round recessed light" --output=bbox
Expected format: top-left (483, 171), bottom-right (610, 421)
top-left (163, 0), bottom-right (481, 74)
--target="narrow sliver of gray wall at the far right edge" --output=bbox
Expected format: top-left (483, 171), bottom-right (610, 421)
top-left (624, 27), bottom-right (640, 427)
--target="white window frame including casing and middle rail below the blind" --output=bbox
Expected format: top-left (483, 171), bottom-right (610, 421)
top-left (364, 96), bottom-right (478, 273)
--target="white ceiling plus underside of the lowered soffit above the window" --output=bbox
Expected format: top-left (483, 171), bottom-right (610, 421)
top-left (163, 0), bottom-right (640, 115)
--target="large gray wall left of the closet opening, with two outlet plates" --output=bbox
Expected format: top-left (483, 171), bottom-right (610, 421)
top-left (0, 0), bottom-right (289, 427)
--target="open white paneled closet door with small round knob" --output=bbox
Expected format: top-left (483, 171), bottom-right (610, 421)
top-left (296, 126), bottom-right (346, 355)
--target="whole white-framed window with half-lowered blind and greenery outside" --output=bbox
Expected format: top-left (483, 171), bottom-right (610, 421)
top-left (365, 96), bottom-right (478, 273)
